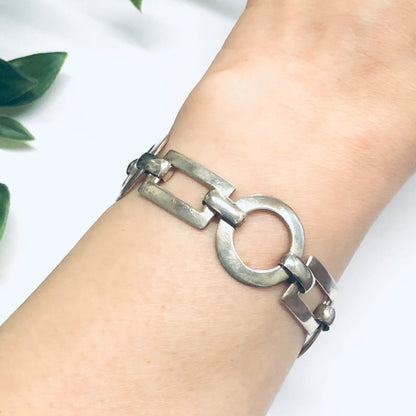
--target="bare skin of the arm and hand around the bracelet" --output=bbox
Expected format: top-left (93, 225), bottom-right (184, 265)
top-left (0, 0), bottom-right (416, 416)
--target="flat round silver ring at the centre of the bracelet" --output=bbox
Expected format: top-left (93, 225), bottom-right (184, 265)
top-left (216, 195), bottom-right (305, 287)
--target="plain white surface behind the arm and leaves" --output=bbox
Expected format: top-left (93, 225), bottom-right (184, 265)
top-left (0, 0), bottom-right (416, 416)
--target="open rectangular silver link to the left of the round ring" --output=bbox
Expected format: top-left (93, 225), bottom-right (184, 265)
top-left (139, 150), bottom-right (235, 229)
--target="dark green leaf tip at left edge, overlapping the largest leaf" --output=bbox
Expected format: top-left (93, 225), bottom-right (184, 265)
top-left (0, 59), bottom-right (37, 105)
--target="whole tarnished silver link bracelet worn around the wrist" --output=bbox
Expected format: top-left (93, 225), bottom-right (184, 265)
top-left (118, 137), bottom-right (337, 356)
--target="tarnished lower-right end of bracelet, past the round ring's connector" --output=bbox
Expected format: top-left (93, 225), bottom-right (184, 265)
top-left (281, 256), bottom-right (337, 356)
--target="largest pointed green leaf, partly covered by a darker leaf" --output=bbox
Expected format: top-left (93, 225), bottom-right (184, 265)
top-left (7, 52), bottom-right (68, 106)
